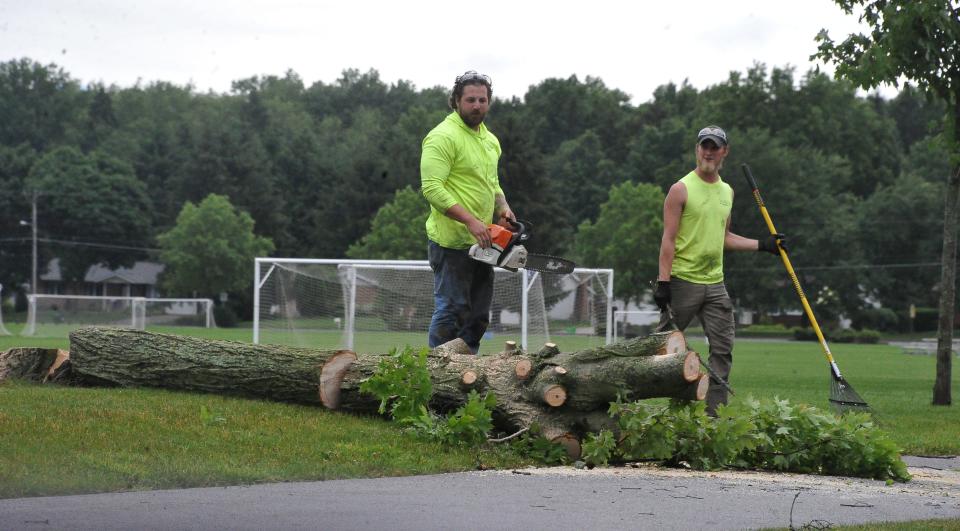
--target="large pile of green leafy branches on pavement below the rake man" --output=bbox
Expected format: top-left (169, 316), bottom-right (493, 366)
top-left (583, 398), bottom-right (910, 481)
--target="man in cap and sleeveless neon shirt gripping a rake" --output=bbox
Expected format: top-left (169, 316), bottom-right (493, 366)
top-left (654, 125), bottom-right (786, 416)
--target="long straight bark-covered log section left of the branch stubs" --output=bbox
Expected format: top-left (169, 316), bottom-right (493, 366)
top-left (69, 328), bottom-right (379, 412)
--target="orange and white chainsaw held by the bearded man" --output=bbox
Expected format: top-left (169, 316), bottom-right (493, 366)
top-left (469, 220), bottom-right (576, 274)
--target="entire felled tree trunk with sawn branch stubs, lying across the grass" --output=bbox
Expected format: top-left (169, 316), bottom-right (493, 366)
top-left (0, 328), bottom-right (708, 456)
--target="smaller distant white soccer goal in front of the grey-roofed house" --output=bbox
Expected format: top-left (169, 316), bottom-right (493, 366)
top-left (21, 295), bottom-right (215, 337)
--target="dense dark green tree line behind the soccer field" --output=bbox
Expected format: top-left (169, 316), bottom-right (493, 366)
top-left (0, 55), bottom-right (950, 327)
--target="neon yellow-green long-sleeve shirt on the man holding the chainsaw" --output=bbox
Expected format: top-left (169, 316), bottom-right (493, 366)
top-left (420, 112), bottom-right (503, 249)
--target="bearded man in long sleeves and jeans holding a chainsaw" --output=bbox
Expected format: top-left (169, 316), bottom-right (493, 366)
top-left (420, 70), bottom-right (516, 354)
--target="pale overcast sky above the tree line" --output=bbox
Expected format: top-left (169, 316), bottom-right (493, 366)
top-left (0, 0), bottom-right (895, 104)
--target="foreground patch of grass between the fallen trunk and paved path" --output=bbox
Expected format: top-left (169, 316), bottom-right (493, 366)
top-left (0, 382), bottom-right (527, 498)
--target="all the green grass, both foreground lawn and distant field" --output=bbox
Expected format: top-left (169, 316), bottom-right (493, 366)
top-left (0, 325), bottom-right (960, 497)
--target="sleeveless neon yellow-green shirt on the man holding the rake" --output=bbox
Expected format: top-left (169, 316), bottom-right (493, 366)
top-left (671, 172), bottom-right (733, 284)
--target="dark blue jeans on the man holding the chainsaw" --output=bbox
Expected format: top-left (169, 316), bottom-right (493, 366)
top-left (427, 241), bottom-right (493, 354)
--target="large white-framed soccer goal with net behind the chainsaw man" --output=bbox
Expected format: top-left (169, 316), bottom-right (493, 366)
top-left (253, 258), bottom-right (613, 353)
